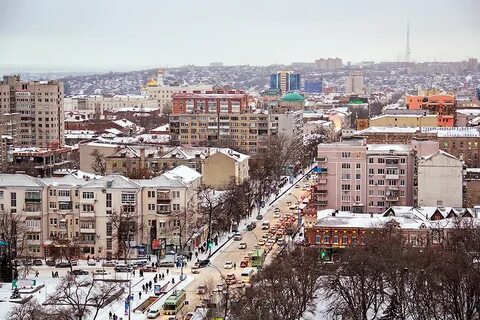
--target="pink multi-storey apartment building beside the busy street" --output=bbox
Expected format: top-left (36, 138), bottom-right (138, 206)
top-left (312, 140), bottom-right (438, 213)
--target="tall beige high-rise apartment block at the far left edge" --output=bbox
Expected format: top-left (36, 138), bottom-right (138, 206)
top-left (0, 75), bottom-right (65, 147)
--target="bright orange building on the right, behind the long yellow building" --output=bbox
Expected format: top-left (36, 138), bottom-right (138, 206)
top-left (405, 94), bottom-right (455, 127)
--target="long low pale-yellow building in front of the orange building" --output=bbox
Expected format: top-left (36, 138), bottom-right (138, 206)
top-left (370, 114), bottom-right (438, 127)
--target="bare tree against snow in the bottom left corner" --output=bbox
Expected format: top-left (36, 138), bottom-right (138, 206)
top-left (47, 275), bottom-right (124, 320)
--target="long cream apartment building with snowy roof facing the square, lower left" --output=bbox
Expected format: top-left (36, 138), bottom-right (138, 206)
top-left (0, 166), bottom-right (201, 258)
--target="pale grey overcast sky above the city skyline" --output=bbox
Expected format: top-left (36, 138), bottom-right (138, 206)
top-left (0, 0), bottom-right (480, 71)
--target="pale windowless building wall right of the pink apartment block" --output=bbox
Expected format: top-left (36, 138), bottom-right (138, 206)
top-left (415, 150), bottom-right (463, 207)
